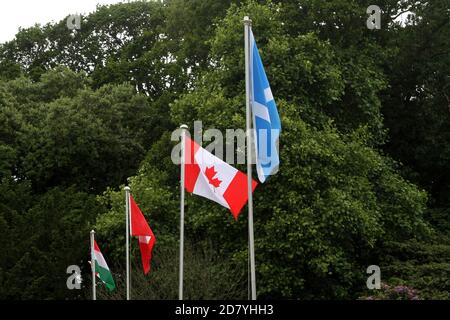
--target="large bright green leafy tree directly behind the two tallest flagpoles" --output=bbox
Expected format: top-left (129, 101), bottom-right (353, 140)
top-left (90, 2), bottom-right (430, 299)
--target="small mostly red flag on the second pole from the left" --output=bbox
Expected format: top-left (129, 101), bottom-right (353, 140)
top-left (130, 194), bottom-right (156, 274)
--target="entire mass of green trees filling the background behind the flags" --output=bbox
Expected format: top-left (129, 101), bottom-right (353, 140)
top-left (0, 0), bottom-right (450, 299)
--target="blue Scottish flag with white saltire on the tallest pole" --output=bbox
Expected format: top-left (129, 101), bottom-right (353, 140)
top-left (250, 32), bottom-right (281, 182)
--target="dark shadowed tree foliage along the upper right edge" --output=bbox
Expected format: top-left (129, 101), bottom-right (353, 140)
top-left (383, 0), bottom-right (450, 207)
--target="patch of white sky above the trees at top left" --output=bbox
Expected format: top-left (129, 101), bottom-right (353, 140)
top-left (0, 0), bottom-right (135, 43)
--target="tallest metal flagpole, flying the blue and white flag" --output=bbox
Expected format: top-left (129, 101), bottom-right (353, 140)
top-left (244, 16), bottom-right (256, 300)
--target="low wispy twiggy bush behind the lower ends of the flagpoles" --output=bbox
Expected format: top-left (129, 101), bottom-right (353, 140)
top-left (98, 243), bottom-right (247, 300)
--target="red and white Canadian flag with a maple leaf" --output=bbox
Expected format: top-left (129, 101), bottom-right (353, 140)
top-left (184, 136), bottom-right (257, 220)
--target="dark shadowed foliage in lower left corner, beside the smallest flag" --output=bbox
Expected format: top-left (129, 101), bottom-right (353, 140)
top-left (0, 186), bottom-right (101, 299)
